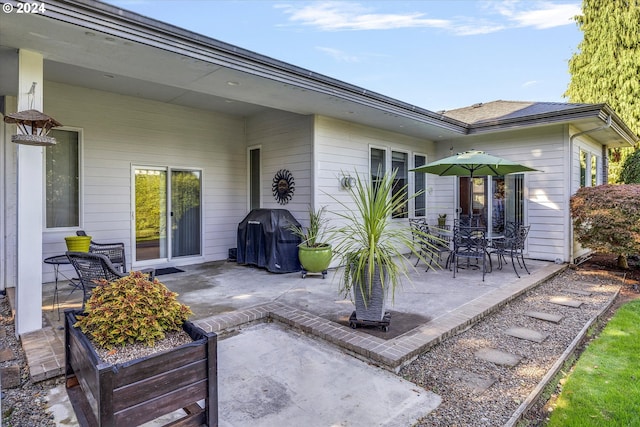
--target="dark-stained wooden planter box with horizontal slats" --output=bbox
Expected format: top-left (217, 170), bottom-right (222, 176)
top-left (65, 310), bottom-right (218, 427)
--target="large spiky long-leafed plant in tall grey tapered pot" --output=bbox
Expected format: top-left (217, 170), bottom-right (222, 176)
top-left (332, 171), bottom-right (430, 326)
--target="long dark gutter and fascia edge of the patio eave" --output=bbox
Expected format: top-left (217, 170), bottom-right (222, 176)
top-left (33, 0), bottom-right (467, 136)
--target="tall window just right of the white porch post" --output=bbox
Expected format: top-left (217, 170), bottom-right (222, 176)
top-left (45, 130), bottom-right (80, 228)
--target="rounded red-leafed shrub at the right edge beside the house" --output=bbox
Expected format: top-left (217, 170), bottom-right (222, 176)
top-left (571, 184), bottom-right (640, 268)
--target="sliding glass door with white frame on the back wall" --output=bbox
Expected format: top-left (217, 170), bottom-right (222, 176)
top-left (133, 167), bottom-right (202, 261)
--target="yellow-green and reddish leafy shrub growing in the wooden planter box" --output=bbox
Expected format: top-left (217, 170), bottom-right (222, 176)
top-left (74, 272), bottom-right (193, 349)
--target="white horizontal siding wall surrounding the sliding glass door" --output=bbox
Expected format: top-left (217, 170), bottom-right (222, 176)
top-left (43, 82), bottom-right (246, 280)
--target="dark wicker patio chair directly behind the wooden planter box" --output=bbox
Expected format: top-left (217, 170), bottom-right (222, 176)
top-left (66, 252), bottom-right (155, 309)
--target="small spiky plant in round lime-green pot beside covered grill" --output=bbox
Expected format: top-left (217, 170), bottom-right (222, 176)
top-left (289, 206), bottom-right (333, 279)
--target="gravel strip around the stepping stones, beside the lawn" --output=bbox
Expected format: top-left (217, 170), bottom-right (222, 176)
top-left (400, 262), bottom-right (623, 427)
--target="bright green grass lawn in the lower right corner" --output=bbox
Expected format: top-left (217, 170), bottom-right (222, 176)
top-left (547, 300), bottom-right (640, 427)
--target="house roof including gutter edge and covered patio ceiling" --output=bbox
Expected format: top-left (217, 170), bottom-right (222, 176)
top-left (0, 0), bottom-right (637, 147)
